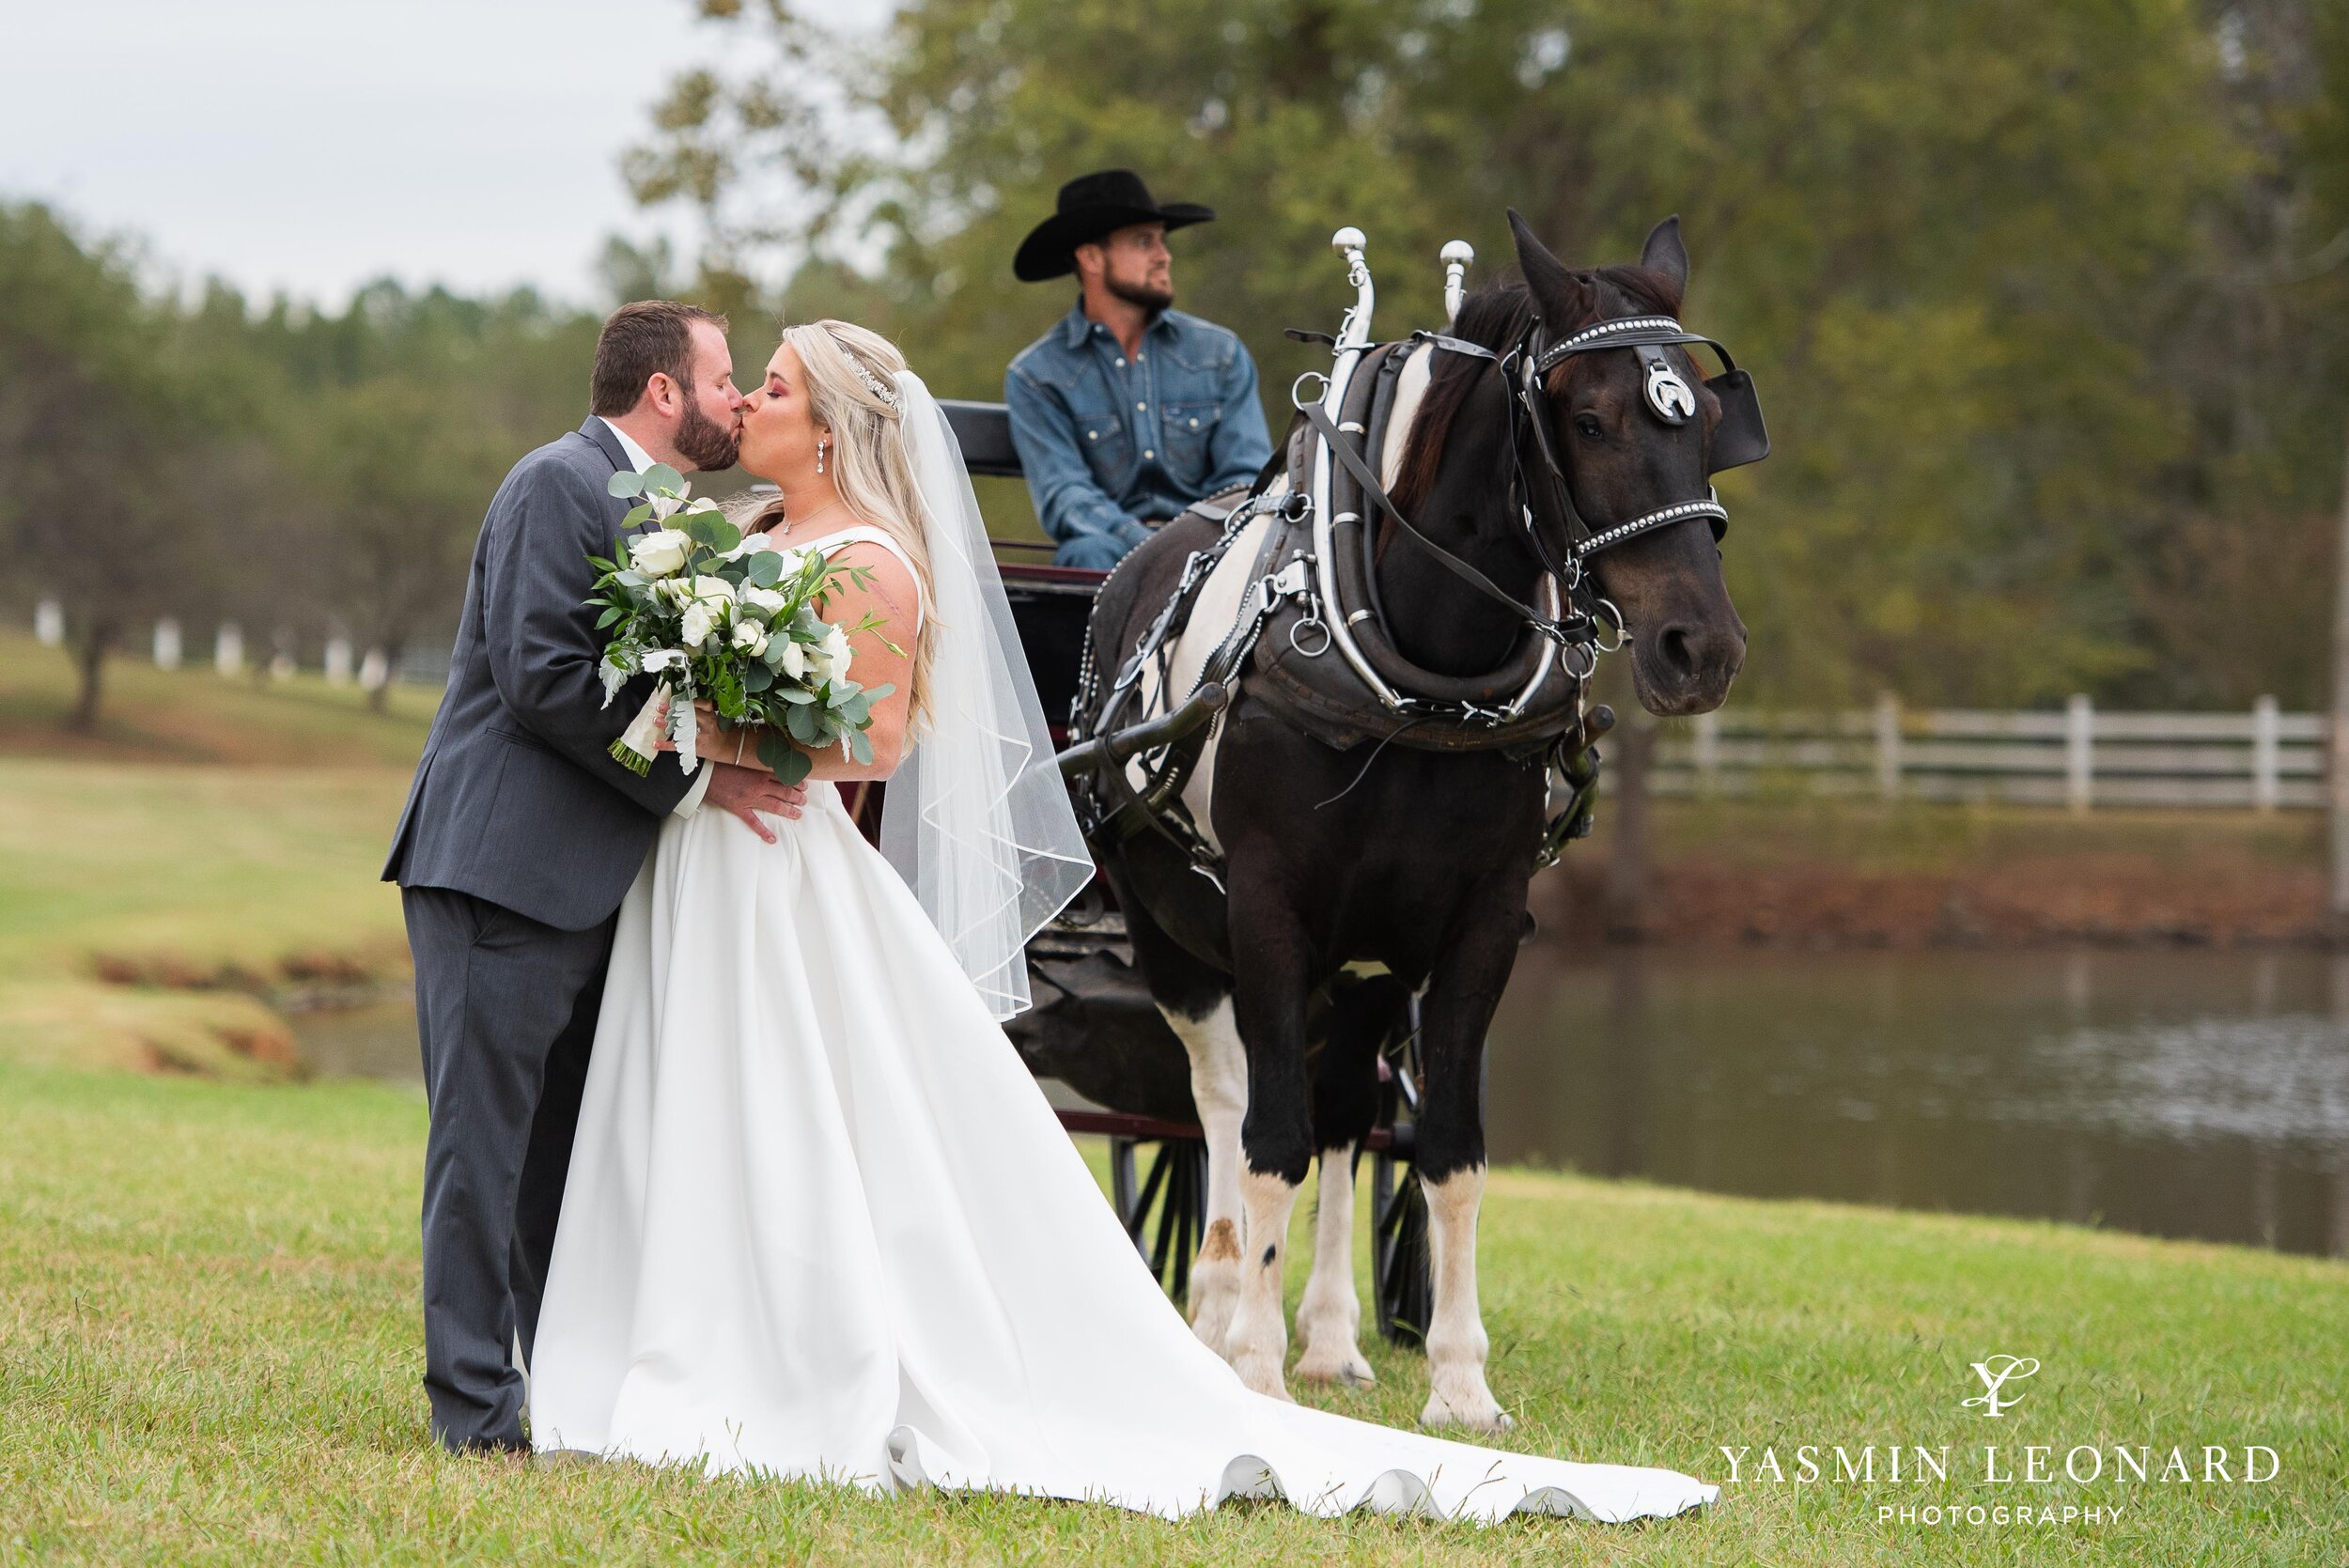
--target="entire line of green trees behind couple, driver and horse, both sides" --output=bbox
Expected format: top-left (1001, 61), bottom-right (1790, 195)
top-left (0, 0), bottom-right (2349, 721)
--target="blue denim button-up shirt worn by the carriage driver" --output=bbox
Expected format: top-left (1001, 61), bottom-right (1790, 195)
top-left (1003, 303), bottom-right (1273, 566)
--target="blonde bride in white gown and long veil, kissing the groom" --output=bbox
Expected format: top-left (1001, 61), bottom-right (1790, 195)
top-left (531, 321), bottom-right (1715, 1521)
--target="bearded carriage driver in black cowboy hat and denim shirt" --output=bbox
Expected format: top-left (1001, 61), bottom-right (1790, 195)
top-left (1003, 169), bottom-right (1273, 570)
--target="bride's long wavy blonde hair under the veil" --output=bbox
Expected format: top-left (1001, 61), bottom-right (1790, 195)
top-left (745, 321), bottom-right (938, 730)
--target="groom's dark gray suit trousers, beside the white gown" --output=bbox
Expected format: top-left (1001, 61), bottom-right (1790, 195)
top-left (402, 887), bottom-right (618, 1451)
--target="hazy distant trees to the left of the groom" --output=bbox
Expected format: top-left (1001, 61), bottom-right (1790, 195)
top-left (0, 204), bottom-right (615, 728)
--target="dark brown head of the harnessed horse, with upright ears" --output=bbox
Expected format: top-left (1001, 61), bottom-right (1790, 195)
top-left (1508, 211), bottom-right (1746, 716)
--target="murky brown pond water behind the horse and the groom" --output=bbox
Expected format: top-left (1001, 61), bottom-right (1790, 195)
top-left (294, 946), bottom-right (2349, 1256)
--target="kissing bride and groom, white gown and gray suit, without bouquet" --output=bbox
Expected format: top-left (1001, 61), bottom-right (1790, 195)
top-left (385, 301), bottom-right (1715, 1521)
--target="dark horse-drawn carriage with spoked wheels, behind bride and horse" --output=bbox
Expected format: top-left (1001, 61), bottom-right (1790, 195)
top-left (893, 399), bottom-right (1433, 1345)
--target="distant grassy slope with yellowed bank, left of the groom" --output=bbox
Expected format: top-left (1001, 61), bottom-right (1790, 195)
top-left (0, 631), bottom-right (418, 1078)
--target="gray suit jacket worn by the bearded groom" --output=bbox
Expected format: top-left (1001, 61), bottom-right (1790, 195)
top-left (383, 418), bottom-right (689, 932)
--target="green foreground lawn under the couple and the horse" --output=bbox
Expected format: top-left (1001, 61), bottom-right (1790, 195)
top-left (0, 1065), bottom-right (2349, 1563)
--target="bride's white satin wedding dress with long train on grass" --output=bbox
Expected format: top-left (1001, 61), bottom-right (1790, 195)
top-left (531, 531), bottom-right (1718, 1521)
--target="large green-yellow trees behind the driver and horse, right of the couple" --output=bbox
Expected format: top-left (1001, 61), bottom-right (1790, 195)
top-left (628, 0), bottom-right (2349, 706)
